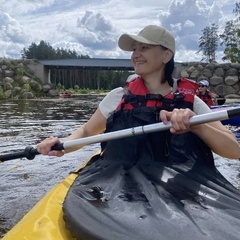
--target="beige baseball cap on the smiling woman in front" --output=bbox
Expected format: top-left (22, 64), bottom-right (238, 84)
top-left (118, 25), bottom-right (175, 54)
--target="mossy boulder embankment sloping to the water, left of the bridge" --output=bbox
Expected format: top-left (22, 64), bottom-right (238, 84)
top-left (0, 58), bottom-right (59, 99)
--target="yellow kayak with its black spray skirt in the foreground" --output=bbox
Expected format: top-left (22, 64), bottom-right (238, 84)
top-left (2, 150), bottom-right (240, 240)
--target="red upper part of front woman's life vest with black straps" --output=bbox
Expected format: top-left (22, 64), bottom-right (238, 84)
top-left (117, 77), bottom-right (198, 110)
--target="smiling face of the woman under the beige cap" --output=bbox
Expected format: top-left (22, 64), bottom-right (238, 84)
top-left (131, 42), bottom-right (170, 78)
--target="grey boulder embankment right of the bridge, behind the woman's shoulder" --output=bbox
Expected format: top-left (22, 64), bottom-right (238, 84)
top-left (177, 62), bottom-right (240, 98)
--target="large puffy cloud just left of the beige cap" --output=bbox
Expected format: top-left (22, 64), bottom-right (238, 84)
top-left (51, 11), bottom-right (118, 56)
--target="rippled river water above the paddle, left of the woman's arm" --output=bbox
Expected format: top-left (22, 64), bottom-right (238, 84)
top-left (0, 96), bottom-right (102, 152)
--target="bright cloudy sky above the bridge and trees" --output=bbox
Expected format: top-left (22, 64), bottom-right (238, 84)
top-left (0, 0), bottom-right (238, 62)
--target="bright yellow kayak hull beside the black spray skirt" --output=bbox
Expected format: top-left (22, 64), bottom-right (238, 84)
top-left (2, 158), bottom-right (91, 240)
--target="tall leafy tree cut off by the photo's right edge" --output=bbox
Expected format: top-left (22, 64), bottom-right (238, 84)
top-left (220, 3), bottom-right (240, 63)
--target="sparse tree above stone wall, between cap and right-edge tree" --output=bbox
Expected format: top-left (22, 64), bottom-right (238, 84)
top-left (198, 23), bottom-right (219, 62)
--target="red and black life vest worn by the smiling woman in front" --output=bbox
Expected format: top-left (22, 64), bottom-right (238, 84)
top-left (101, 75), bottom-right (212, 164)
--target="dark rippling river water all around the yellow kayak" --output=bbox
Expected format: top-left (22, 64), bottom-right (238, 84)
top-left (0, 95), bottom-right (240, 238)
